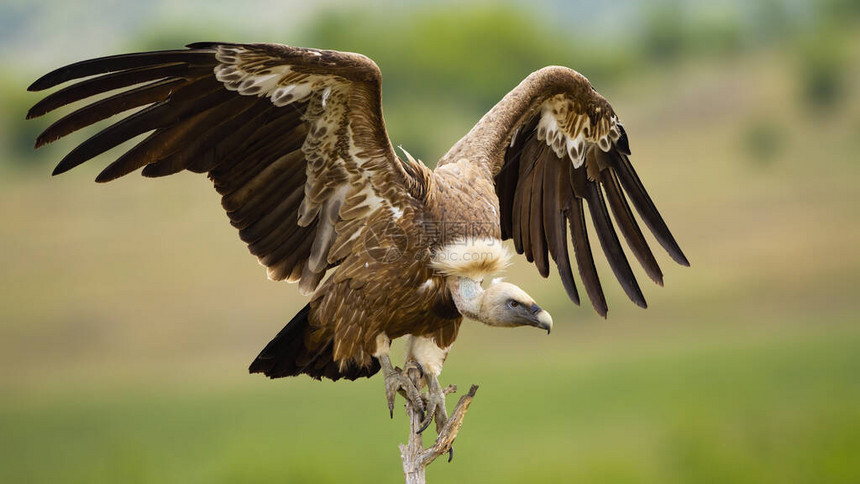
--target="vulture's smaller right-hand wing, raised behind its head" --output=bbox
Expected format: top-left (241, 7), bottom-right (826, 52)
top-left (445, 67), bottom-right (689, 317)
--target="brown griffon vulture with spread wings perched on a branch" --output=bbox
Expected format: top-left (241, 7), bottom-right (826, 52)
top-left (27, 43), bottom-right (688, 426)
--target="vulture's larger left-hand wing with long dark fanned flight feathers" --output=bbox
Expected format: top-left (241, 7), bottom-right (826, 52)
top-left (27, 43), bottom-right (423, 293)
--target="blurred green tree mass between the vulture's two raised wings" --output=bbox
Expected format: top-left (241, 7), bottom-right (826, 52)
top-left (306, 4), bottom-right (635, 164)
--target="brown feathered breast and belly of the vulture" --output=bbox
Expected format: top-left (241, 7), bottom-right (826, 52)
top-left (311, 207), bottom-right (462, 367)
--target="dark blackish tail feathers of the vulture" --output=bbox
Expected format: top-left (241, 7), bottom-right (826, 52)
top-left (248, 304), bottom-right (380, 381)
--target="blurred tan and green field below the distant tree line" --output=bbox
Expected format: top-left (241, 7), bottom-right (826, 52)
top-left (0, 20), bottom-right (860, 483)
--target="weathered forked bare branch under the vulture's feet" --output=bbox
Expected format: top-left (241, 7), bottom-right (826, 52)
top-left (400, 366), bottom-right (478, 484)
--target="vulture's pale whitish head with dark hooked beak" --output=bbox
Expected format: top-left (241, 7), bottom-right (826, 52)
top-left (451, 277), bottom-right (552, 333)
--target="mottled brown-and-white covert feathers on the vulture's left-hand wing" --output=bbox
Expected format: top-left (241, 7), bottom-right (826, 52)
top-left (208, 45), bottom-right (416, 294)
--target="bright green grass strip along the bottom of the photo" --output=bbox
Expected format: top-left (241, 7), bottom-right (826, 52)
top-left (0, 321), bottom-right (860, 483)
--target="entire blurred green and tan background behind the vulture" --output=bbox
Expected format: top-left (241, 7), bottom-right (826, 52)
top-left (0, 0), bottom-right (860, 483)
